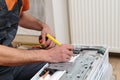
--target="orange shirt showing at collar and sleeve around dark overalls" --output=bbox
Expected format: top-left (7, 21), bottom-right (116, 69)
top-left (5, 0), bottom-right (29, 11)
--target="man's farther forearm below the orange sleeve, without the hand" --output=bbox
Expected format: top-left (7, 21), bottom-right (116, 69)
top-left (19, 12), bottom-right (46, 31)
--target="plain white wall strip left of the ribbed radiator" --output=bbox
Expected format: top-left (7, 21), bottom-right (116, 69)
top-left (46, 0), bottom-right (70, 43)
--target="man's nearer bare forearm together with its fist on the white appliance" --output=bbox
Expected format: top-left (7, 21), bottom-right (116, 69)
top-left (0, 44), bottom-right (73, 66)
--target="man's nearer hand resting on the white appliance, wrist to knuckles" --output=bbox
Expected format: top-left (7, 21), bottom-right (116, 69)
top-left (47, 44), bottom-right (73, 62)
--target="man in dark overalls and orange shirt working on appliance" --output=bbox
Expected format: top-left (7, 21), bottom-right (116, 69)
top-left (0, 0), bottom-right (73, 80)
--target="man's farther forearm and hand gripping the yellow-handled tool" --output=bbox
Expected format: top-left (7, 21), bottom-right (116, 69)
top-left (19, 12), bottom-right (55, 48)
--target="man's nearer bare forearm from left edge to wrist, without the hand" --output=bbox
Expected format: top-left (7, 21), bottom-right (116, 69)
top-left (0, 46), bottom-right (47, 66)
